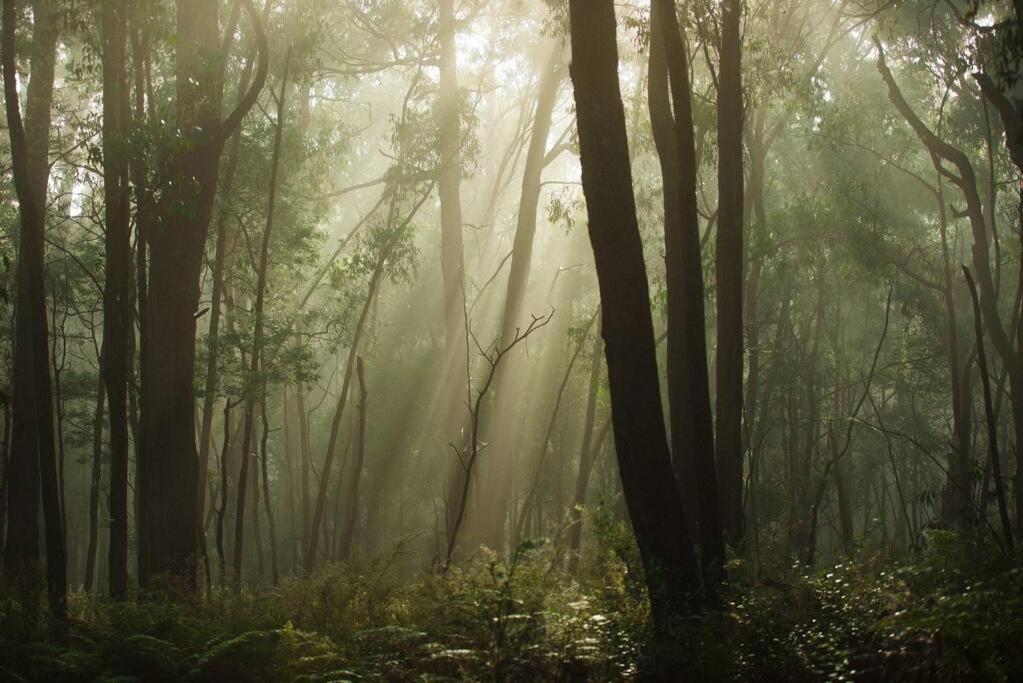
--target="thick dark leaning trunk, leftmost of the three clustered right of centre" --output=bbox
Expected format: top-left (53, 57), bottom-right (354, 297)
top-left (569, 0), bottom-right (699, 633)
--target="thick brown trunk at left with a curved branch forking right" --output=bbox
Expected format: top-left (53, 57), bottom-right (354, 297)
top-left (136, 0), bottom-right (267, 590)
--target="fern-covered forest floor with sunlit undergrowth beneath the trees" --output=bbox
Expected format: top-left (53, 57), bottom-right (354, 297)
top-left (0, 532), bottom-right (1023, 681)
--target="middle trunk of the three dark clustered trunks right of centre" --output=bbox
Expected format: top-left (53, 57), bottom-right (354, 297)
top-left (650, 0), bottom-right (724, 595)
